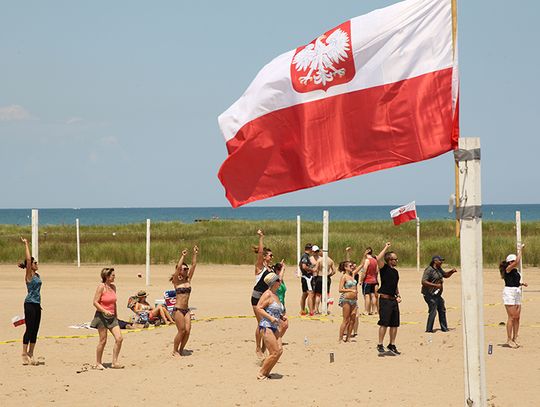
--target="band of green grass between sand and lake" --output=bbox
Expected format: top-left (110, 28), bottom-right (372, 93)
top-left (0, 220), bottom-right (540, 267)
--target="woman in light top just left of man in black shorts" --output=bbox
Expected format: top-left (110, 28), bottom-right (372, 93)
top-left (338, 260), bottom-right (358, 342)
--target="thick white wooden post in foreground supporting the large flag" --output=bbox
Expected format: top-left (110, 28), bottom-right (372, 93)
top-left (454, 138), bottom-right (487, 407)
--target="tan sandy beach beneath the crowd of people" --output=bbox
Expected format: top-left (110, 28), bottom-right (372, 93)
top-left (0, 264), bottom-right (540, 406)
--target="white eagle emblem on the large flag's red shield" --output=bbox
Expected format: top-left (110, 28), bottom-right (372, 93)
top-left (292, 28), bottom-right (350, 87)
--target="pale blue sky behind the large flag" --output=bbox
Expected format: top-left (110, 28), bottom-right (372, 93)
top-left (0, 0), bottom-right (540, 208)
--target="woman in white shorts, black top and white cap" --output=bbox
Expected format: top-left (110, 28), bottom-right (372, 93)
top-left (499, 244), bottom-right (528, 348)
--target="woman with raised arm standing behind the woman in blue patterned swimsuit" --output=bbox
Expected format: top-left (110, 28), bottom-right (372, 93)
top-left (251, 229), bottom-right (274, 358)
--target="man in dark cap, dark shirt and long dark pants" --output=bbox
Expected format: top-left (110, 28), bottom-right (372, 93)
top-left (422, 256), bottom-right (457, 332)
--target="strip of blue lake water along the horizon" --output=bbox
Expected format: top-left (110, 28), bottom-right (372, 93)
top-left (0, 204), bottom-right (540, 225)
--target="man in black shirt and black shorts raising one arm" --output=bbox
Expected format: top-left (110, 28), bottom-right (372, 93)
top-left (377, 242), bottom-right (401, 356)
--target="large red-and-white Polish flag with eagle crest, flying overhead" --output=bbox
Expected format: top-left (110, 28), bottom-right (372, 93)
top-left (218, 0), bottom-right (459, 207)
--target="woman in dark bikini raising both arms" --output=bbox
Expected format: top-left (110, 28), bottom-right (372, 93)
top-left (170, 246), bottom-right (199, 357)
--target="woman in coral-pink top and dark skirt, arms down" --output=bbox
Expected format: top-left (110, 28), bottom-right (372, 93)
top-left (90, 267), bottom-right (124, 370)
